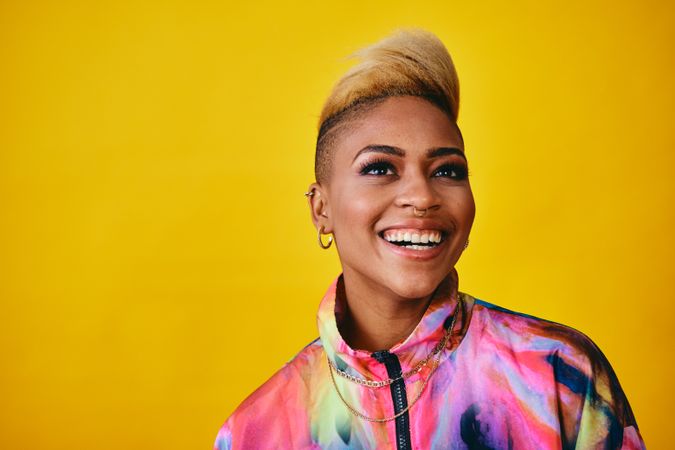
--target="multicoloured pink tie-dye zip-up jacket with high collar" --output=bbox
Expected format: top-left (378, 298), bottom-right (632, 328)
top-left (214, 270), bottom-right (645, 450)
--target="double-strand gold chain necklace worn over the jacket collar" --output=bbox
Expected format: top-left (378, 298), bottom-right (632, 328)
top-left (326, 292), bottom-right (462, 423)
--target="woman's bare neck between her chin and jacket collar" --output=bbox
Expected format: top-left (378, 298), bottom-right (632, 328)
top-left (336, 273), bottom-right (452, 352)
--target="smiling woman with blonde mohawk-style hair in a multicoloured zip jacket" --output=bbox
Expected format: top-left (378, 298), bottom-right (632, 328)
top-left (215, 31), bottom-right (644, 450)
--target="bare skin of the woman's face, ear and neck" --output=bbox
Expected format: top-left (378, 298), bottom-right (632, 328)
top-left (308, 96), bottom-right (475, 351)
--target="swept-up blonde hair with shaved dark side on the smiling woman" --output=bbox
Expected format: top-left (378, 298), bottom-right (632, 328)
top-left (314, 29), bottom-right (459, 182)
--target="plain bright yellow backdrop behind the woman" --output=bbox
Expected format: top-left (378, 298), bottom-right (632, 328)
top-left (0, 0), bottom-right (675, 449)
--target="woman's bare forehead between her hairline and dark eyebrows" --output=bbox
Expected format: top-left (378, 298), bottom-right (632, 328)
top-left (335, 96), bottom-right (464, 161)
